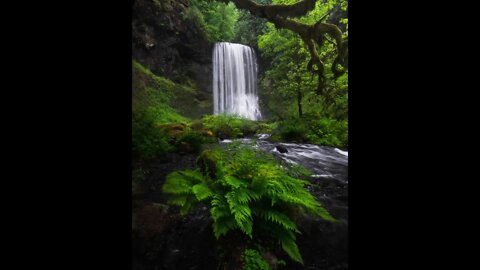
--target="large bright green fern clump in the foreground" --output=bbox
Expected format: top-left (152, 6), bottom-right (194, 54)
top-left (163, 144), bottom-right (335, 263)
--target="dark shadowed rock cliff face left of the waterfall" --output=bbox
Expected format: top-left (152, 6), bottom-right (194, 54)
top-left (132, 0), bottom-right (213, 112)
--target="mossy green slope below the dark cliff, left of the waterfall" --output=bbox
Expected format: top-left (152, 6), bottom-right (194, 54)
top-left (132, 61), bottom-right (214, 159)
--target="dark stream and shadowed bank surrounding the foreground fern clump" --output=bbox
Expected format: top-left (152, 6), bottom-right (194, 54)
top-left (132, 139), bottom-right (348, 269)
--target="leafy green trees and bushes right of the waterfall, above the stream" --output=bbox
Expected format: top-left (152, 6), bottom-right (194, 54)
top-left (258, 0), bottom-right (348, 147)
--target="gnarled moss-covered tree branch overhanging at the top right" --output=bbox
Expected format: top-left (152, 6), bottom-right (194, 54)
top-left (216, 0), bottom-right (348, 99)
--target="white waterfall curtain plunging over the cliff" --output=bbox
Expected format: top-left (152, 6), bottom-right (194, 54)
top-left (213, 42), bottom-right (262, 120)
